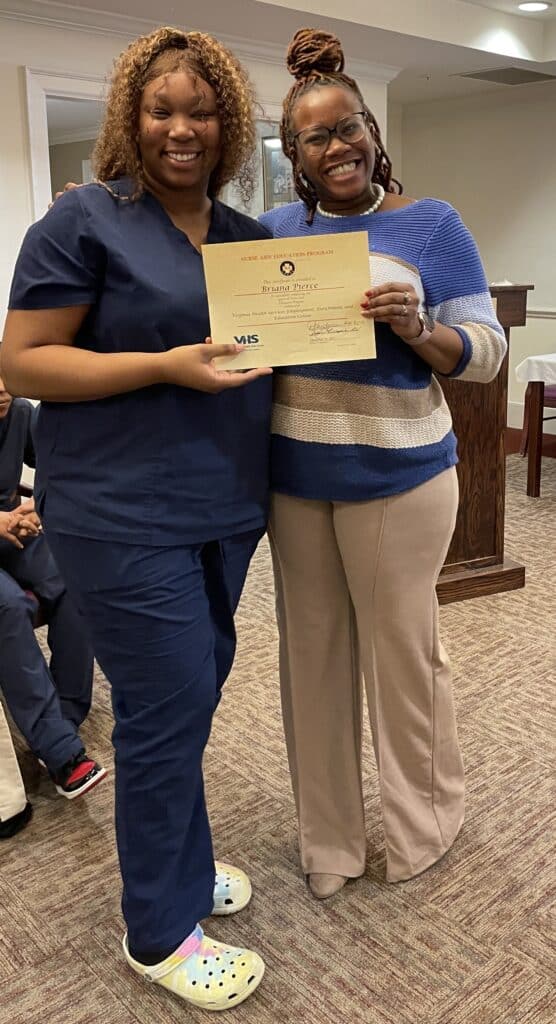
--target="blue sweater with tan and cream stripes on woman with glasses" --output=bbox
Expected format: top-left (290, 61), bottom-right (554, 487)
top-left (260, 199), bottom-right (506, 501)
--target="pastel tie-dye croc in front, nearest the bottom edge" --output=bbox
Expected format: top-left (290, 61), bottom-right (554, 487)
top-left (123, 925), bottom-right (264, 1010)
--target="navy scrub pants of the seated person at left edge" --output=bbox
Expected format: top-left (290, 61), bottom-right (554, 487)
top-left (0, 536), bottom-right (93, 772)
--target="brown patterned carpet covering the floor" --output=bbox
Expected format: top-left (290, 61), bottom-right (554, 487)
top-left (0, 456), bottom-right (556, 1024)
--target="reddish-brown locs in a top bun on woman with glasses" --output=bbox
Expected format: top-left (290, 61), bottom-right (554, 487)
top-left (280, 29), bottom-right (401, 224)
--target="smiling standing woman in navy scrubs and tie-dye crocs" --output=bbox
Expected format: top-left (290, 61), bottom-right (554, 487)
top-left (2, 29), bottom-right (270, 1009)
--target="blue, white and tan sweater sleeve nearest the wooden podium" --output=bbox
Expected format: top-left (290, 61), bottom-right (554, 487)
top-left (419, 207), bottom-right (508, 383)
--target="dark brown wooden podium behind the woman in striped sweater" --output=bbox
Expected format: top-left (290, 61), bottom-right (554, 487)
top-left (436, 285), bottom-right (533, 604)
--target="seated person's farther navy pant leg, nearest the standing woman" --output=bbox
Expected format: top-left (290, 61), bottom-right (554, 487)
top-left (3, 536), bottom-right (93, 729)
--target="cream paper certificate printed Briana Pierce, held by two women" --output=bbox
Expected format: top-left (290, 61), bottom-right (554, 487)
top-left (202, 231), bottom-right (376, 370)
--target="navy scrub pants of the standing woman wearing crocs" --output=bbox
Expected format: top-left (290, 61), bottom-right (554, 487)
top-left (46, 532), bottom-right (262, 952)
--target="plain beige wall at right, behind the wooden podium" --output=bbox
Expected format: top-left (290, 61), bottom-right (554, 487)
top-left (402, 83), bottom-right (556, 427)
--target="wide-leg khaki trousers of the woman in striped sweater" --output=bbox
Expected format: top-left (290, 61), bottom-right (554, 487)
top-left (269, 468), bottom-right (464, 882)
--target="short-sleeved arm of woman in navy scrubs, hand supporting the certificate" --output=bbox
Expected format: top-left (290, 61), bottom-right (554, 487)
top-left (0, 188), bottom-right (271, 401)
